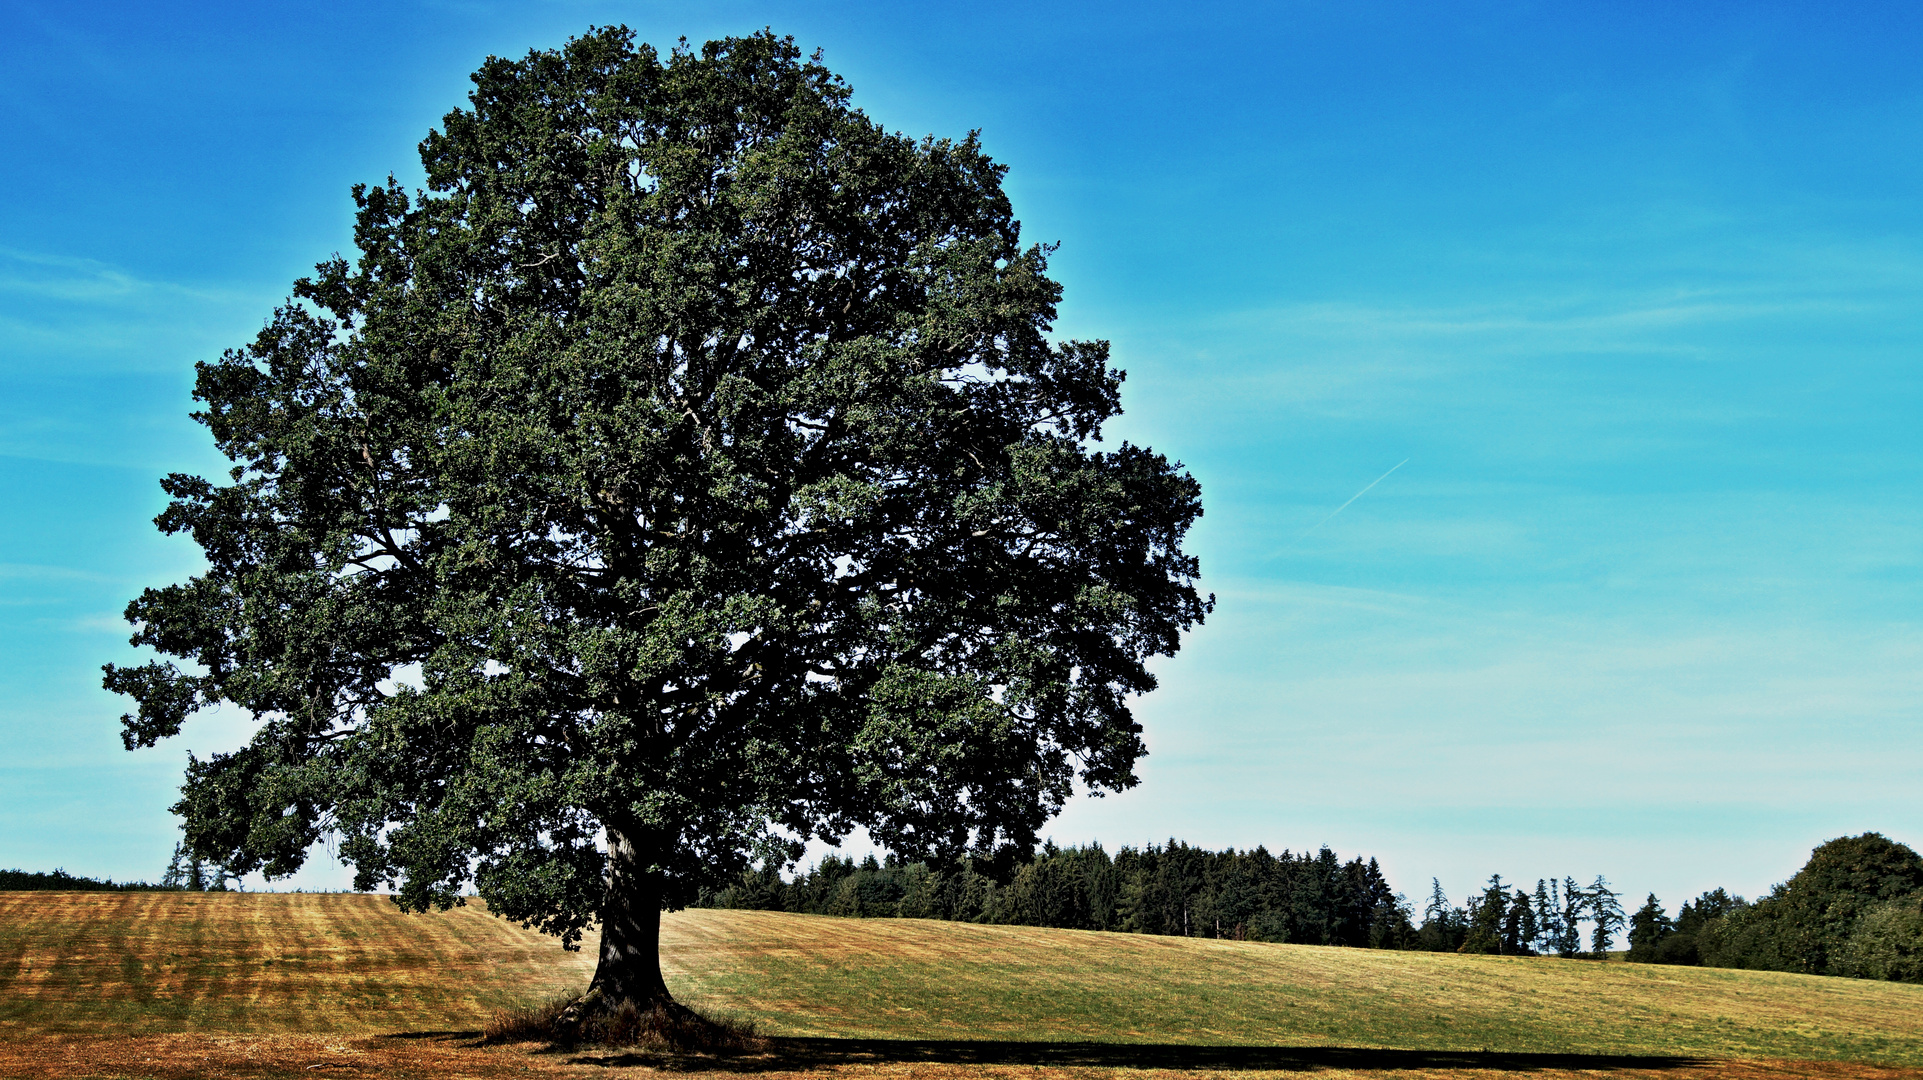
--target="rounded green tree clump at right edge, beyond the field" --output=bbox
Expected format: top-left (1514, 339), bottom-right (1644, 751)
top-left (1629, 832), bottom-right (1923, 982)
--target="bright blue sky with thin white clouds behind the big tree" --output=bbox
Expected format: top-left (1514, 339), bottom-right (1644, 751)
top-left (0, 2), bottom-right (1923, 909)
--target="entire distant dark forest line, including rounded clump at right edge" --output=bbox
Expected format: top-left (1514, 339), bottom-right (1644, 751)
top-left (698, 832), bottom-right (1923, 982)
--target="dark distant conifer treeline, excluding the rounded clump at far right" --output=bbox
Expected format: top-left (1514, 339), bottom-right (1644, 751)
top-left (696, 840), bottom-right (1623, 957)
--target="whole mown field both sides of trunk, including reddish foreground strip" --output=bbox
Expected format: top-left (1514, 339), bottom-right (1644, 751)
top-left (0, 894), bottom-right (1923, 1080)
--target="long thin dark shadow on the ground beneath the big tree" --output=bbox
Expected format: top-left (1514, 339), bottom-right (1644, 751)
top-left (569, 1038), bottom-right (1719, 1072)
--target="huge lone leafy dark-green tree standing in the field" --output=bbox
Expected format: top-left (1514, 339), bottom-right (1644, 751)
top-left (106, 29), bottom-right (1213, 1005)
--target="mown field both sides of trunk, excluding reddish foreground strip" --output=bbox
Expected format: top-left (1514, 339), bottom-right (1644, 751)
top-left (0, 892), bottom-right (1923, 1067)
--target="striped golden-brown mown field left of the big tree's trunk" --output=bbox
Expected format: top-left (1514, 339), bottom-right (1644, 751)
top-left (0, 892), bottom-right (590, 1034)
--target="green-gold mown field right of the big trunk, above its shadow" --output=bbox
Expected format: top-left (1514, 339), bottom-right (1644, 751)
top-left (662, 911), bottom-right (1923, 1067)
